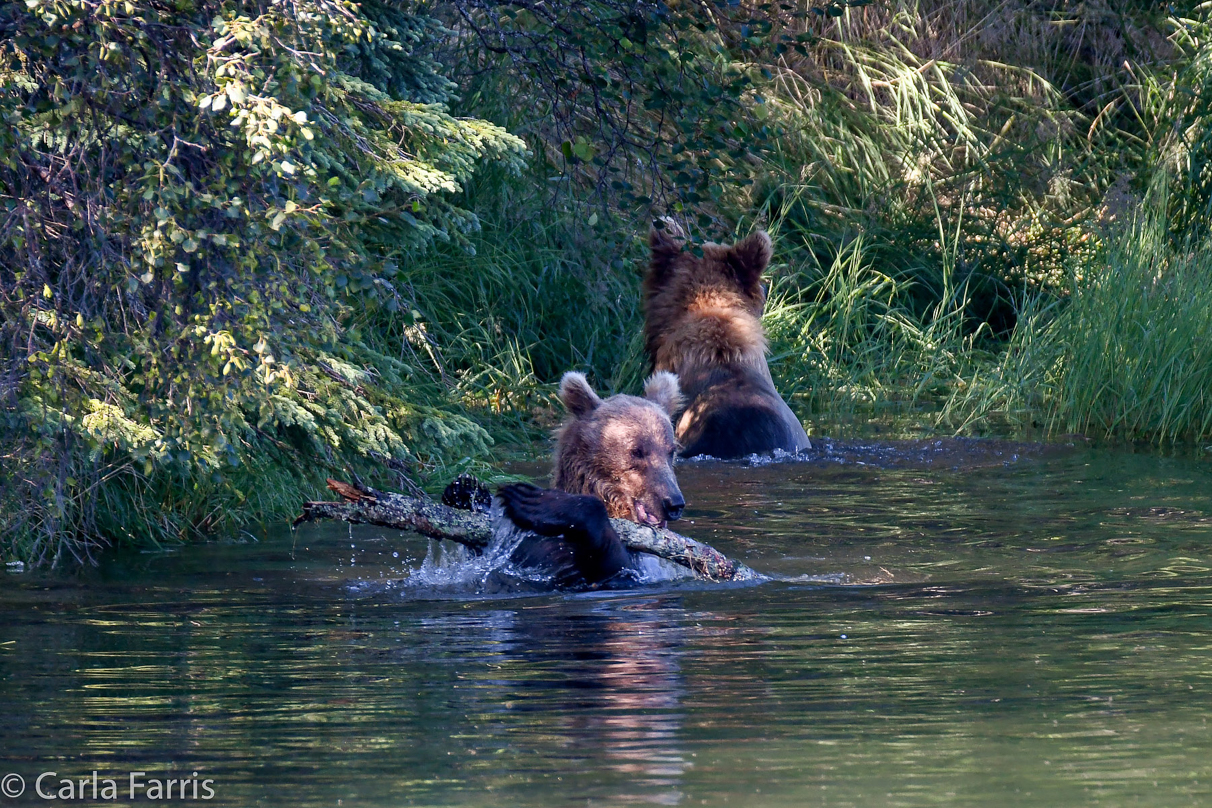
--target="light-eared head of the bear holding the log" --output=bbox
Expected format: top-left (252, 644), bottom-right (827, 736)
top-left (551, 373), bottom-right (686, 526)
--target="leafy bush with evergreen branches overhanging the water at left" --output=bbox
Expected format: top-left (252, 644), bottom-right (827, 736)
top-left (0, 0), bottom-right (525, 563)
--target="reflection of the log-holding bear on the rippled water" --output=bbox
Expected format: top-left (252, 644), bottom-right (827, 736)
top-left (400, 592), bottom-right (698, 804)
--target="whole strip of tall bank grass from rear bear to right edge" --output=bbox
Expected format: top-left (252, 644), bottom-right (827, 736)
top-left (767, 204), bottom-right (1212, 443)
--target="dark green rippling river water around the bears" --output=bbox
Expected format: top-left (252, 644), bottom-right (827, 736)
top-left (0, 445), bottom-right (1212, 807)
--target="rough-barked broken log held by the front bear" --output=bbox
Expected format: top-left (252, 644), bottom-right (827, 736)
top-left (295, 480), bottom-right (765, 580)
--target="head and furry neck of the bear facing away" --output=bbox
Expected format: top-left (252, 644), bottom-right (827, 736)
top-left (644, 219), bottom-right (772, 373)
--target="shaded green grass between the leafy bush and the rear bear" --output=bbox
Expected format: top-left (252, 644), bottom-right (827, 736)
top-left (364, 172), bottom-right (647, 423)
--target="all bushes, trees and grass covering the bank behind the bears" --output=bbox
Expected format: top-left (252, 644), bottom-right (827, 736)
top-left (0, 0), bottom-right (1212, 563)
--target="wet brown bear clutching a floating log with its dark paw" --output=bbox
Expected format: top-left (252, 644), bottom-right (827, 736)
top-left (498, 373), bottom-right (686, 588)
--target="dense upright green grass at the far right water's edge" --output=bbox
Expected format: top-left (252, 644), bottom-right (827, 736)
top-left (1050, 206), bottom-right (1212, 442)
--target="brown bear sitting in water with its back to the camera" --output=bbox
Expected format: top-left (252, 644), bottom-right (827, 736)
top-left (644, 220), bottom-right (811, 458)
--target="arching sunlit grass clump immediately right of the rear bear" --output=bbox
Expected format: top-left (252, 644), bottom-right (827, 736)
top-left (765, 230), bottom-right (1013, 432)
